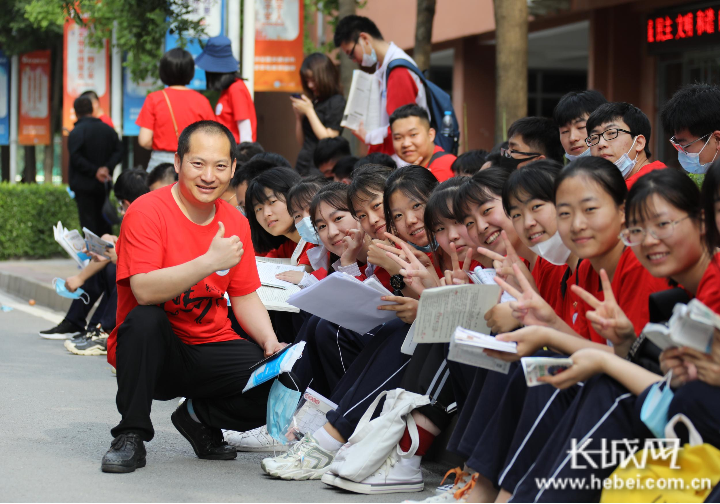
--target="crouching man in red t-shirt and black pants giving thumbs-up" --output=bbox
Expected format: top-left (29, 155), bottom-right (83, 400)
top-left (102, 121), bottom-right (283, 473)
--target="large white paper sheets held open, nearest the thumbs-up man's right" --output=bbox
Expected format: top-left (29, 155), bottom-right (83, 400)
top-left (287, 273), bottom-right (395, 334)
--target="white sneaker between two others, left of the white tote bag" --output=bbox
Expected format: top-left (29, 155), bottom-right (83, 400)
top-left (260, 434), bottom-right (335, 481)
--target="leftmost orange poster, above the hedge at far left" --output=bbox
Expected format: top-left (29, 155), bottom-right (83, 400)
top-left (18, 51), bottom-right (50, 145)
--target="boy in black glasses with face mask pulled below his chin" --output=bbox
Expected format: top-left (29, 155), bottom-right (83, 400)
top-left (585, 102), bottom-right (667, 189)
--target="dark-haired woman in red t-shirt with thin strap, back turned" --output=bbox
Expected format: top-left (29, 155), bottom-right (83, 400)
top-left (135, 48), bottom-right (215, 172)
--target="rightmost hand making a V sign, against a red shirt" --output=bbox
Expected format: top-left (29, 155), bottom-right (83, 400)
top-left (571, 269), bottom-right (636, 357)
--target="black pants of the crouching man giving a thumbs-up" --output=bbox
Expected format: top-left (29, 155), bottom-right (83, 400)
top-left (111, 306), bottom-right (272, 441)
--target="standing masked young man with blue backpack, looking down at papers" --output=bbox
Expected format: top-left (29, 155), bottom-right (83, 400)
top-left (334, 16), bottom-right (429, 156)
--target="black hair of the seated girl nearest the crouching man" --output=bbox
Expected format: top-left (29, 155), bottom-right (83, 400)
top-left (245, 168), bottom-right (302, 254)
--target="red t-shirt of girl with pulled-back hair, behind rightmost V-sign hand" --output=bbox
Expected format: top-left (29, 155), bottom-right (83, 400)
top-left (577, 247), bottom-right (670, 344)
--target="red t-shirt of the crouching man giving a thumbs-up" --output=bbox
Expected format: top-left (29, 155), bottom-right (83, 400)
top-left (108, 186), bottom-right (260, 366)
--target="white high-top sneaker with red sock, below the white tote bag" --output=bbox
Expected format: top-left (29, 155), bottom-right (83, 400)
top-left (332, 452), bottom-right (425, 495)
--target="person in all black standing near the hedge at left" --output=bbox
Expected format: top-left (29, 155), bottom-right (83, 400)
top-left (68, 96), bottom-right (123, 236)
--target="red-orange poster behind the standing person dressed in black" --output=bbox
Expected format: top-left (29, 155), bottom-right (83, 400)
top-left (63, 20), bottom-right (110, 135)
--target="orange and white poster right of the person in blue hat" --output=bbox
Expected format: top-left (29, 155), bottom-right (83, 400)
top-left (255, 0), bottom-right (303, 93)
